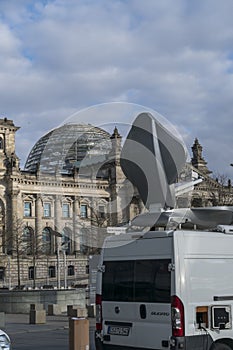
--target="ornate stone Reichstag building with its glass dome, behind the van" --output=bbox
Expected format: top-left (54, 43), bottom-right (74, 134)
top-left (0, 118), bottom-right (233, 288)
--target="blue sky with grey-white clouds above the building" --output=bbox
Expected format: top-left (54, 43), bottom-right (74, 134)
top-left (0, 0), bottom-right (233, 179)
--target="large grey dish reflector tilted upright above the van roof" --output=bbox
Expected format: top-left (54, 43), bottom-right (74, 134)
top-left (120, 113), bottom-right (187, 211)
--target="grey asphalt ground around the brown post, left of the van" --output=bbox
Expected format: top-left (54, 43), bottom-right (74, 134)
top-left (4, 314), bottom-right (95, 350)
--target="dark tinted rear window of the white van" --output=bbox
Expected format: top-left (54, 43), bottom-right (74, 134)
top-left (102, 259), bottom-right (171, 303)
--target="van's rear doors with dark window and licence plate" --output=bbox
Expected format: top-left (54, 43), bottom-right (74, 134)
top-left (102, 255), bottom-right (172, 349)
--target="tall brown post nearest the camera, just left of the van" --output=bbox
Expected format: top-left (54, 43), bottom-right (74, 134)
top-left (69, 317), bottom-right (89, 350)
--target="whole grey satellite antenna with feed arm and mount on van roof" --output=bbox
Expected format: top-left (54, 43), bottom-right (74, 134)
top-left (120, 113), bottom-right (233, 228)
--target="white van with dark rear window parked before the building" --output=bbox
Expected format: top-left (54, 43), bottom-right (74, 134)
top-left (96, 230), bottom-right (233, 350)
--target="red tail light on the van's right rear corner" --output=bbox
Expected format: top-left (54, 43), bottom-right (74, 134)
top-left (171, 295), bottom-right (184, 337)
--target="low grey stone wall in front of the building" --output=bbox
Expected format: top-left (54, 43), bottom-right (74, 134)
top-left (0, 288), bottom-right (86, 313)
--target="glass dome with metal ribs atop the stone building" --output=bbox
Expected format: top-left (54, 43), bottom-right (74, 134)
top-left (24, 123), bottom-right (111, 174)
